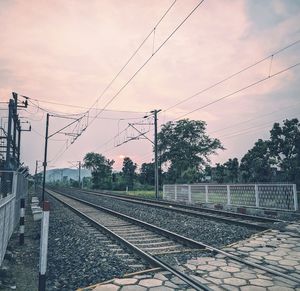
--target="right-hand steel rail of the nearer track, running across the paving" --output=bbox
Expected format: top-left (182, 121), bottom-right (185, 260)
top-left (48, 191), bottom-right (300, 284)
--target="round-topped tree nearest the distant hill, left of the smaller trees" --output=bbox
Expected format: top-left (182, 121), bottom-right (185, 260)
top-left (83, 152), bottom-right (115, 189)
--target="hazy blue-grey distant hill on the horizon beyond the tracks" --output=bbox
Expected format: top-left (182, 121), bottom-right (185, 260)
top-left (46, 168), bottom-right (91, 182)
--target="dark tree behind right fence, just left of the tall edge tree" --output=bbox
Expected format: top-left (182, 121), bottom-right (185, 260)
top-left (240, 139), bottom-right (273, 182)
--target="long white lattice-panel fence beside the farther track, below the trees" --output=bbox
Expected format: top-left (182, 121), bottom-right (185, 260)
top-left (163, 184), bottom-right (298, 211)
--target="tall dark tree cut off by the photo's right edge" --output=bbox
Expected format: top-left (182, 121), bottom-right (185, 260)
top-left (269, 118), bottom-right (300, 183)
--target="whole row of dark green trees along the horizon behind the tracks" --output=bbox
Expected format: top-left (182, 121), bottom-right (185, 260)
top-left (84, 118), bottom-right (300, 190)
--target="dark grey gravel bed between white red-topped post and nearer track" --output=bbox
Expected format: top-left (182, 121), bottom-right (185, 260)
top-left (47, 193), bottom-right (146, 290)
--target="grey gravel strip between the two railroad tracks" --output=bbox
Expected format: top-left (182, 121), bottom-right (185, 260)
top-left (58, 190), bottom-right (258, 247)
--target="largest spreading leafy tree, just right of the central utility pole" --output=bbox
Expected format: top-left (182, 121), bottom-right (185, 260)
top-left (158, 119), bottom-right (224, 182)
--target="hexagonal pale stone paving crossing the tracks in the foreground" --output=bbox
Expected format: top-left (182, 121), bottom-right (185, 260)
top-left (78, 224), bottom-right (300, 291)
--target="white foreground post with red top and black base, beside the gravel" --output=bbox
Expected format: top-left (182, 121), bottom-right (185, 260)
top-left (39, 201), bottom-right (50, 291)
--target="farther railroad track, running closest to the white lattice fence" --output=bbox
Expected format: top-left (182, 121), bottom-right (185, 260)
top-left (58, 189), bottom-right (286, 230)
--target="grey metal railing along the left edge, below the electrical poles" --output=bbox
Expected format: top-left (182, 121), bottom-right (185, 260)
top-left (0, 171), bottom-right (28, 266)
